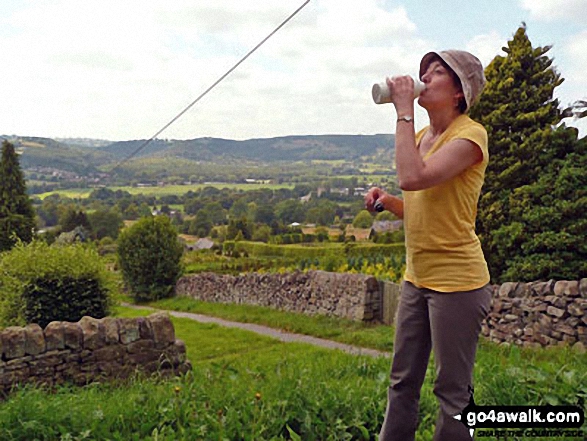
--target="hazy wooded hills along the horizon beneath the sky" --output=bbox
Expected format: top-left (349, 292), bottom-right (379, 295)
top-left (4, 134), bottom-right (394, 177)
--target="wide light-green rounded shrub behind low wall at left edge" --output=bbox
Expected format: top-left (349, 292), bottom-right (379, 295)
top-left (0, 240), bottom-right (112, 327)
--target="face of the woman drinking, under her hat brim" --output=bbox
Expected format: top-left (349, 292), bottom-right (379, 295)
top-left (418, 60), bottom-right (463, 110)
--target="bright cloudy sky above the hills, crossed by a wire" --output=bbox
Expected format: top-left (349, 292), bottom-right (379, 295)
top-left (0, 0), bottom-right (587, 141)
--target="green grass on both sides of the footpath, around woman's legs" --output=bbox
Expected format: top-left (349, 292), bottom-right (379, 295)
top-left (0, 302), bottom-right (587, 441)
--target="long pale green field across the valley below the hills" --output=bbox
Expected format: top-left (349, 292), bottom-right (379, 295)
top-left (34, 183), bottom-right (294, 199)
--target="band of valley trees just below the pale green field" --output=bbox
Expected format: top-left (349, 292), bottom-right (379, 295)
top-left (35, 185), bottom-right (390, 242)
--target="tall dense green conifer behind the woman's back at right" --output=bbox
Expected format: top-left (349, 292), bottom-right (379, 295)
top-left (471, 25), bottom-right (587, 282)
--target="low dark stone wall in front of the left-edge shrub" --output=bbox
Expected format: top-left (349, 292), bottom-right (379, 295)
top-left (0, 313), bottom-right (191, 393)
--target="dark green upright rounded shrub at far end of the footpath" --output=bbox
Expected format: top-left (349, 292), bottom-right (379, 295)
top-left (117, 216), bottom-right (183, 302)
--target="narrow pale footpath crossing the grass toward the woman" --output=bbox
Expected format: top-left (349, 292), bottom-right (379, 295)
top-left (122, 303), bottom-right (390, 358)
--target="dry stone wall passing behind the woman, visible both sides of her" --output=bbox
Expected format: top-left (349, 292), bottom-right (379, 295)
top-left (176, 271), bottom-right (587, 348)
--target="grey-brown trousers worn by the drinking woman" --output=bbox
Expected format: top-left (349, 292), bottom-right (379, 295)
top-left (379, 282), bottom-right (491, 441)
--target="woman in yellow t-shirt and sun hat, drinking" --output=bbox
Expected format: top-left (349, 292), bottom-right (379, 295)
top-left (365, 50), bottom-right (491, 441)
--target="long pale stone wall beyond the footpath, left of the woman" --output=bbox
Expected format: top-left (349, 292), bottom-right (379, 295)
top-left (176, 271), bottom-right (382, 320)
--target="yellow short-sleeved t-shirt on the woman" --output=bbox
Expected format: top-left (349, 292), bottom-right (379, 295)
top-left (403, 115), bottom-right (489, 292)
